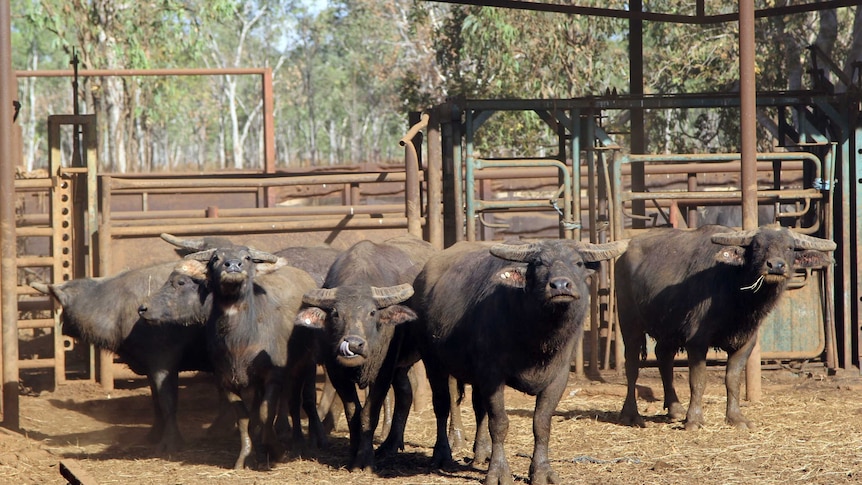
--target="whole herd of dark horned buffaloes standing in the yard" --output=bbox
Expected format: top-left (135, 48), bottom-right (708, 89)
top-left (33, 225), bottom-right (835, 484)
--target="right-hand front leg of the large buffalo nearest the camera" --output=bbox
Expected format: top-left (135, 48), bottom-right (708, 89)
top-left (530, 360), bottom-right (569, 485)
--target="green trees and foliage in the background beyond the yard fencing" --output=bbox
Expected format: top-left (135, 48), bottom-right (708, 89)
top-left (12, 0), bottom-right (858, 171)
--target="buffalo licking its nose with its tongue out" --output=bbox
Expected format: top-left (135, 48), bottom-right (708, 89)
top-left (296, 236), bottom-right (434, 470)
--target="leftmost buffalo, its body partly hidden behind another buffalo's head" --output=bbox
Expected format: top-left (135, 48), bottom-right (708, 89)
top-left (31, 262), bottom-right (223, 452)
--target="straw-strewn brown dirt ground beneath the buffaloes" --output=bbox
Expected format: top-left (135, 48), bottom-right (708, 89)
top-left (0, 366), bottom-right (862, 485)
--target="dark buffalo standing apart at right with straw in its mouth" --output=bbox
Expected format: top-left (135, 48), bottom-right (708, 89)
top-left (615, 225), bottom-right (835, 429)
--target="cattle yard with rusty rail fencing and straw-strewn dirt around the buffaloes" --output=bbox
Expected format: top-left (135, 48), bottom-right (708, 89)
top-left (5, 4), bottom-right (862, 485)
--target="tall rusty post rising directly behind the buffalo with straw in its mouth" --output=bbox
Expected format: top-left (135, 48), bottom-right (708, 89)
top-left (739, 0), bottom-right (761, 402)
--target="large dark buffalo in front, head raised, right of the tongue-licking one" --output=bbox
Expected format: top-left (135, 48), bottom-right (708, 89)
top-left (414, 240), bottom-right (625, 485)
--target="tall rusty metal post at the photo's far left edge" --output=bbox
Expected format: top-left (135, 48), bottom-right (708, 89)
top-left (0, 0), bottom-right (20, 431)
